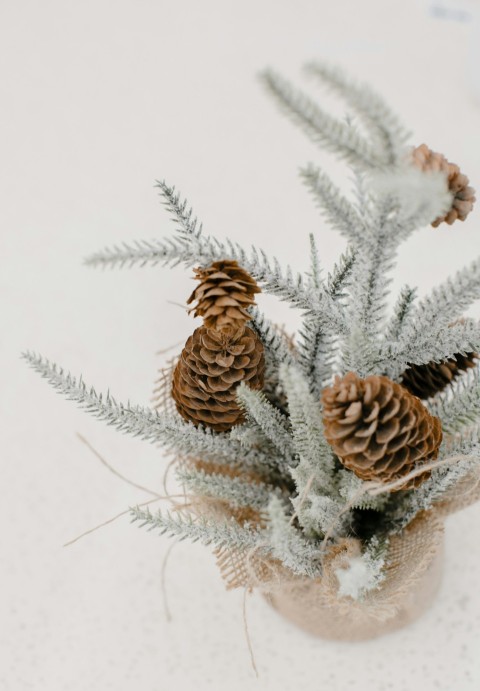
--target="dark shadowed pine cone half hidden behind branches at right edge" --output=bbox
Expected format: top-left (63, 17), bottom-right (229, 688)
top-left (401, 353), bottom-right (478, 400)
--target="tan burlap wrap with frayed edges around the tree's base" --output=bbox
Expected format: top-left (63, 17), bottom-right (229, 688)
top-left (211, 460), bottom-right (480, 641)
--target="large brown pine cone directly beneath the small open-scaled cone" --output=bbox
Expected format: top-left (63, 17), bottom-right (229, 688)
top-left (172, 326), bottom-right (265, 432)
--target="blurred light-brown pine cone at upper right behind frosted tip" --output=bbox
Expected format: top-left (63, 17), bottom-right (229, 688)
top-left (412, 144), bottom-right (475, 228)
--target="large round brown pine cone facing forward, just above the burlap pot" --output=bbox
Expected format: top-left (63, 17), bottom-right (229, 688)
top-left (322, 372), bottom-right (442, 489)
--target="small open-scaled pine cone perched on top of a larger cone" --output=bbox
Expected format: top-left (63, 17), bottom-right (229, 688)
top-left (187, 259), bottom-right (260, 332)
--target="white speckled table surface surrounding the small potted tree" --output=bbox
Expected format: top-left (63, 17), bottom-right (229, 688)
top-left (0, 0), bottom-right (480, 691)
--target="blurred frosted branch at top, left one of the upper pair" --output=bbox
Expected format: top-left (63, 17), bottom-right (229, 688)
top-left (261, 70), bottom-right (387, 168)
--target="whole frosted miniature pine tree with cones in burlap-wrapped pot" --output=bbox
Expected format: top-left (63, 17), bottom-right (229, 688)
top-left (25, 64), bottom-right (480, 640)
